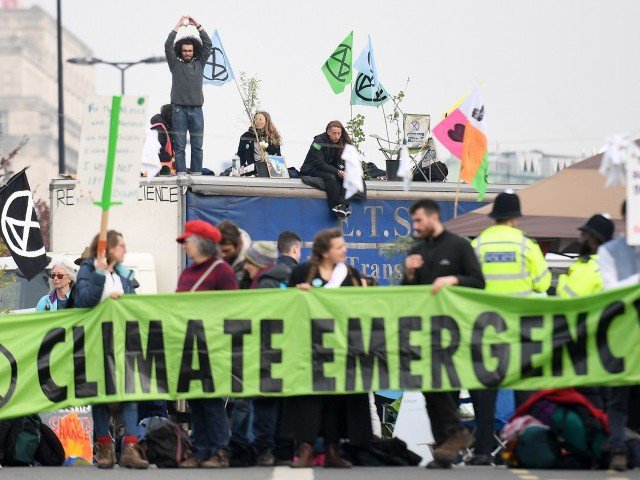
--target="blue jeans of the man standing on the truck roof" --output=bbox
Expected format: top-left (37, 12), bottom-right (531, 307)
top-left (171, 105), bottom-right (204, 173)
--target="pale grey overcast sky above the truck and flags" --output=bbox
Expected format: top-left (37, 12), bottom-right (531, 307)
top-left (27, 0), bottom-right (640, 172)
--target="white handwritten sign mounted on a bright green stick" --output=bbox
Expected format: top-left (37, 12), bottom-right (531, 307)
top-left (76, 96), bottom-right (148, 209)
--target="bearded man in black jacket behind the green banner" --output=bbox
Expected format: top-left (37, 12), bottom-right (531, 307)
top-left (402, 200), bottom-right (484, 468)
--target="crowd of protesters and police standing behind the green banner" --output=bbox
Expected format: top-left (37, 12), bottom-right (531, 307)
top-left (25, 192), bottom-right (640, 470)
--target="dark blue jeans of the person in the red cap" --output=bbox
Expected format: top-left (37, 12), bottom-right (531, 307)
top-left (189, 398), bottom-right (229, 460)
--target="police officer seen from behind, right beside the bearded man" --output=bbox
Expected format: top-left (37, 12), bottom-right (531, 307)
top-left (469, 190), bottom-right (551, 465)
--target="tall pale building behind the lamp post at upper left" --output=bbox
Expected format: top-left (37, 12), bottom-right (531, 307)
top-left (0, 6), bottom-right (94, 199)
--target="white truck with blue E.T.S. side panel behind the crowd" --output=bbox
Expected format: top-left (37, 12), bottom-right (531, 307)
top-left (50, 176), bottom-right (507, 293)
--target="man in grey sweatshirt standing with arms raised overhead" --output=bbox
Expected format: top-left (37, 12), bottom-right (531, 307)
top-left (164, 15), bottom-right (211, 175)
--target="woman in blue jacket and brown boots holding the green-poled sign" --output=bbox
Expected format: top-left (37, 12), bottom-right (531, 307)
top-left (74, 230), bottom-right (149, 468)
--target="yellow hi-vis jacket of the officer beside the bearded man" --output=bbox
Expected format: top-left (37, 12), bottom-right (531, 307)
top-left (471, 225), bottom-right (551, 296)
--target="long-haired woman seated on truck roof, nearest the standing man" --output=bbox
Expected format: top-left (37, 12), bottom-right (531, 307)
top-left (237, 112), bottom-right (282, 171)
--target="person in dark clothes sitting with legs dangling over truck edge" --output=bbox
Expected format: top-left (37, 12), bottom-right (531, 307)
top-left (300, 120), bottom-right (353, 218)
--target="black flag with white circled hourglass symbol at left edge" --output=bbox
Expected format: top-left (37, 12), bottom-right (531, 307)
top-left (0, 170), bottom-right (49, 280)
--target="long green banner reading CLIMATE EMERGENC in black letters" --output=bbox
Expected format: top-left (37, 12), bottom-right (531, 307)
top-left (0, 286), bottom-right (640, 419)
